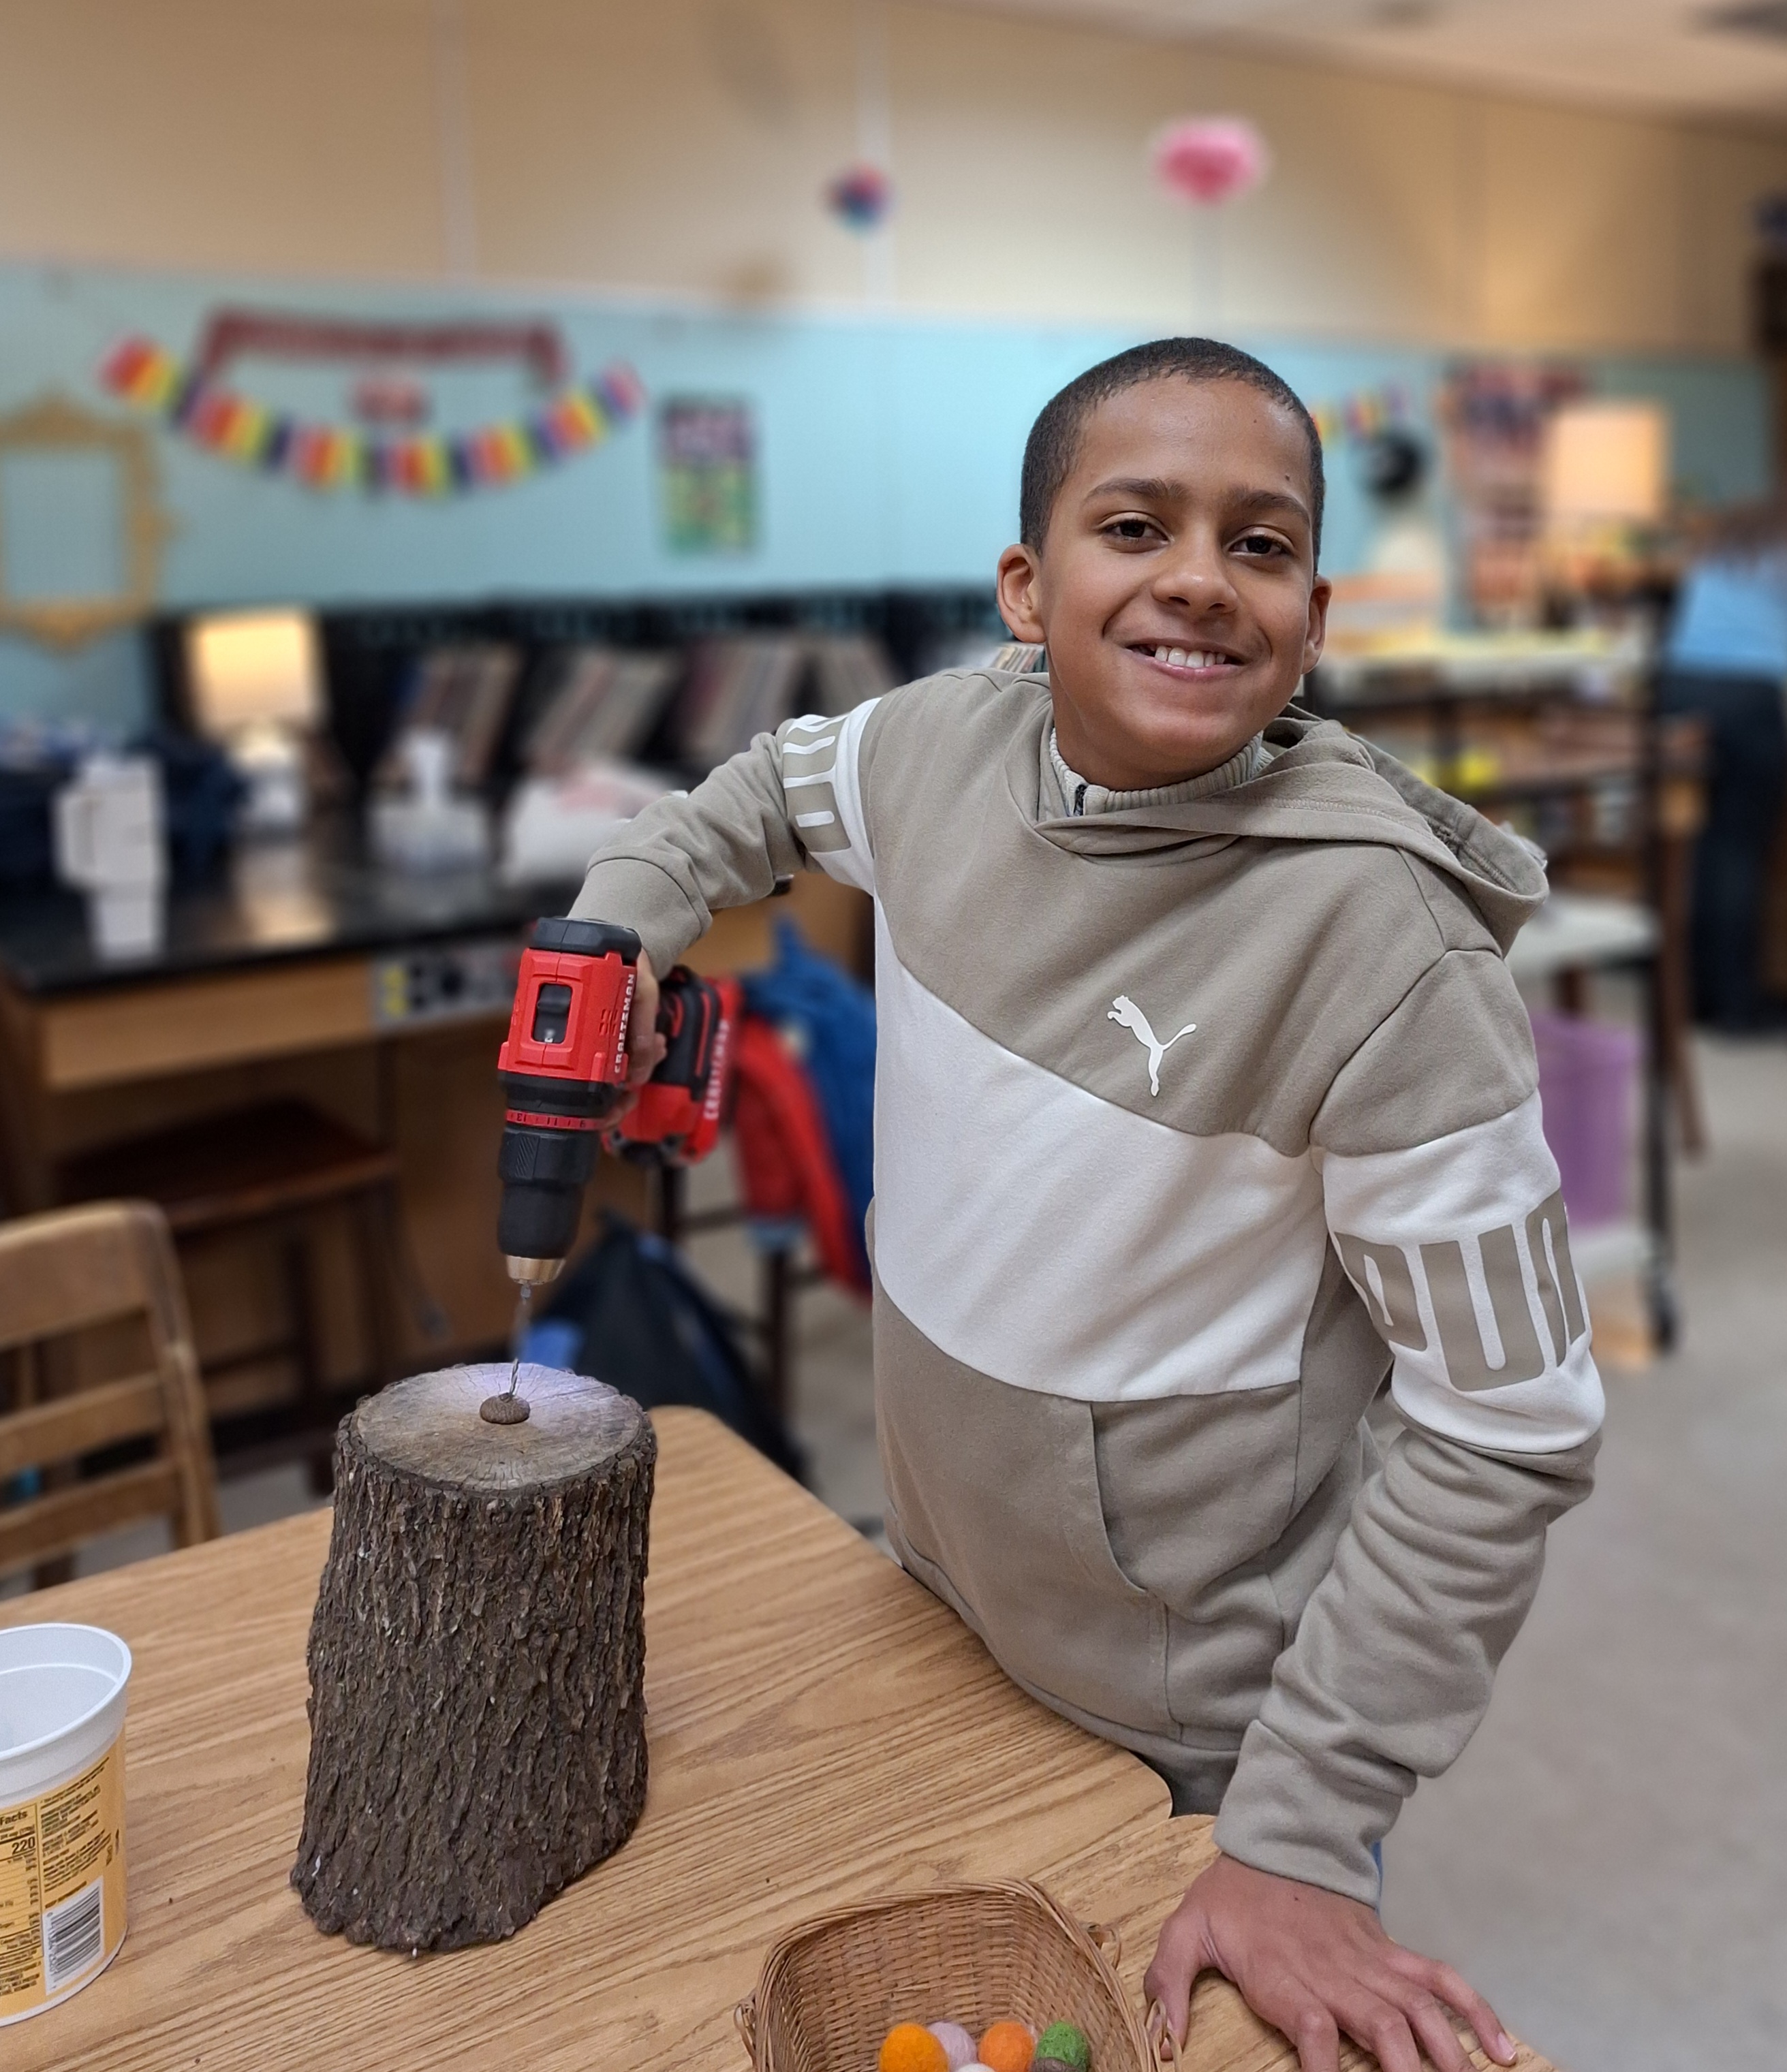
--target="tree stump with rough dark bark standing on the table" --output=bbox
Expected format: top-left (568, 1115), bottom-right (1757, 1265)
top-left (292, 1366), bottom-right (657, 1950)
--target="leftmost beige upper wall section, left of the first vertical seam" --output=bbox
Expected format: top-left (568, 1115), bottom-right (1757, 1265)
top-left (0, 0), bottom-right (441, 274)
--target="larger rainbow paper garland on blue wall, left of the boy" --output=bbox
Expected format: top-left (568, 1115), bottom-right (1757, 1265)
top-left (99, 338), bottom-right (644, 497)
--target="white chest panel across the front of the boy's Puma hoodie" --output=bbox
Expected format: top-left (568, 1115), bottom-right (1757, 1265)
top-left (875, 905), bottom-right (1326, 1402)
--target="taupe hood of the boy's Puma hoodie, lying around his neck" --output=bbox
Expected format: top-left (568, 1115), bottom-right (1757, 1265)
top-left (1008, 676), bottom-right (1547, 955)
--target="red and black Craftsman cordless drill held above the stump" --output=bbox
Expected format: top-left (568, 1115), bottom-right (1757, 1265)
top-left (495, 920), bottom-right (738, 1289)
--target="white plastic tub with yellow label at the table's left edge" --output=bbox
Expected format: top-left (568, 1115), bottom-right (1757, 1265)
top-left (0, 1627), bottom-right (131, 2026)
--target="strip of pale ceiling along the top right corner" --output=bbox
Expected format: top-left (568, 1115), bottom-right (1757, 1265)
top-left (953, 0), bottom-right (1787, 127)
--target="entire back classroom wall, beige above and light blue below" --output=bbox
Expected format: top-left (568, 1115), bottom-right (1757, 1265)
top-left (0, 0), bottom-right (1787, 727)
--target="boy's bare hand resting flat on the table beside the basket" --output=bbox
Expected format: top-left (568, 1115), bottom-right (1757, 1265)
top-left (1143, 1857), bottom-right (1515, 2072)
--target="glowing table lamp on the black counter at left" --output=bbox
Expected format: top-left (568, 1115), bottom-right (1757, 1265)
top-left (187, 611), bottom-right (324, 833)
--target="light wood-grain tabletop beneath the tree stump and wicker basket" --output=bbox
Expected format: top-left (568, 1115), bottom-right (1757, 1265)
top-left (0, 1411), bottom-right (1544, 2072)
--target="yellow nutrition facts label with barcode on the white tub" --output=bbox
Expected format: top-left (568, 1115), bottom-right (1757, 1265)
top-left (0, 1736), bottom-right (125, 2022)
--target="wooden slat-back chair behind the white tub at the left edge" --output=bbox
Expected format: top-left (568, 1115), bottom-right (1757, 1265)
top-left (0, 1202), bottom-right (218, 1577)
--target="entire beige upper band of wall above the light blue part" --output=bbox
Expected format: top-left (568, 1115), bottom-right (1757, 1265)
top-left (0, 0), bottom-right (1787, 350)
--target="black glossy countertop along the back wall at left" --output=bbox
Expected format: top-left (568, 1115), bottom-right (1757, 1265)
top-left (0, 825), bottom-right (576, 999)
